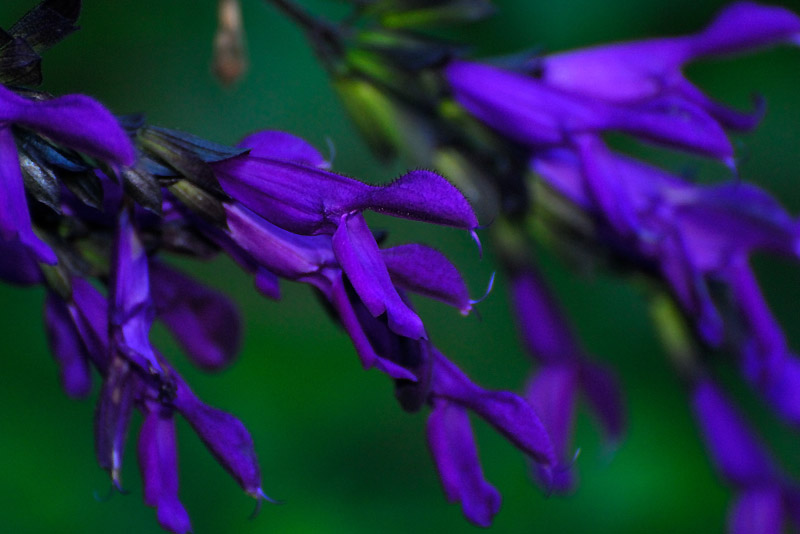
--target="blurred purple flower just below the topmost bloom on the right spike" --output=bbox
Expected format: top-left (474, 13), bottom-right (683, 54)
top-left (445, 61), bottom-right (733, 163)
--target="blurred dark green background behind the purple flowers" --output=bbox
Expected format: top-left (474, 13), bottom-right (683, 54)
top-left (0, 0), bottom-right (800, 534)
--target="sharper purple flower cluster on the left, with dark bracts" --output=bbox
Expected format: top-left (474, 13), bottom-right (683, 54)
top-left (0, 2), bottom-right (555, 532)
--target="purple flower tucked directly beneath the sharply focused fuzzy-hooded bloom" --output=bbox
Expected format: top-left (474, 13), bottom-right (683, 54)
top-left (222, 204), bottom-right (471, 379)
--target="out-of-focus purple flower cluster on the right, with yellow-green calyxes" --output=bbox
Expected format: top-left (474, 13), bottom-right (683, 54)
top-left (264, 0), bottom-right (800, 532)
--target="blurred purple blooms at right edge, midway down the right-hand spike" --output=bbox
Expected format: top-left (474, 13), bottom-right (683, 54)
top-left (533, 142), bottom-right (800, 422)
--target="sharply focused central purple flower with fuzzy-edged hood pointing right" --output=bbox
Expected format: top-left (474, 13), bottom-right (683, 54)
top-left (214, 132), bottom-right (478, 339)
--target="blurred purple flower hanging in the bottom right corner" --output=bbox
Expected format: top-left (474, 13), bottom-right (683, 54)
top-left (692, 379), bottom-right (800, 534)
